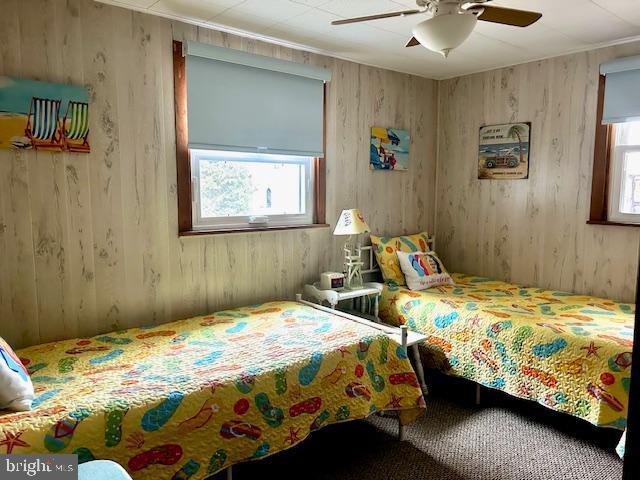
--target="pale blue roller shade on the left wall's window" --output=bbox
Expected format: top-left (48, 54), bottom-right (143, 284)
top-left (181, 43), bottom-right (330, 156)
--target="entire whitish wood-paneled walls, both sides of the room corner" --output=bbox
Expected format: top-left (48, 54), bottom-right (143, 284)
top-left (0, 0), bottom-right (640, 347)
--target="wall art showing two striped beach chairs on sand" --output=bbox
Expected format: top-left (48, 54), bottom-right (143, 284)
top-left (0, 76), bottom-right (91, 153)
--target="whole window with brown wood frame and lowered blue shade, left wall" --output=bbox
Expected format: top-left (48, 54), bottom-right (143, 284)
top-left (173, 41), bottom-right (331, 235)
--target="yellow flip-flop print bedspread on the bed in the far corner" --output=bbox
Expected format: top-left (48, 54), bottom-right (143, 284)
top-left (380, 274), bottom-right (635, 429)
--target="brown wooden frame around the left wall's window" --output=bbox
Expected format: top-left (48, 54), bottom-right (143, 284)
top-left (173, 40), bottom-right (329, 236)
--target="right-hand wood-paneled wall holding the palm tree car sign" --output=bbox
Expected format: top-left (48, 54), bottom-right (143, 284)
top-left (436, 43), bottom-right (640, 302)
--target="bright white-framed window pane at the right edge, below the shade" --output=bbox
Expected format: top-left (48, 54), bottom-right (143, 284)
top-left (609, 122), bottom-right (640, 223)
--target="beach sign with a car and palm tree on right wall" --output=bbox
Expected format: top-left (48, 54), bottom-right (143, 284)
top-left (478, 122), bottom-right (531, 180)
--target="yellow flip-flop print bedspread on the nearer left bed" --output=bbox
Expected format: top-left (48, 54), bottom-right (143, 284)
top-left (0, 302), bottom-right (424, 479)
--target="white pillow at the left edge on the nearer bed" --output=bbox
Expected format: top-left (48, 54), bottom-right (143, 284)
top-left (0, 337), bottom-right (35, 412)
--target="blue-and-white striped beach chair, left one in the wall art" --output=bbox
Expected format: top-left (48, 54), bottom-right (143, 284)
top-left (25, 97), bottom-right (63, 150)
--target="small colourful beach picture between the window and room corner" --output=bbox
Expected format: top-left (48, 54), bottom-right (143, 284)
top-left (369, 127), bottom-right (411, 170)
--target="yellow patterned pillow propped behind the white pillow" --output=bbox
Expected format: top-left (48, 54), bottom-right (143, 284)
top-left (371, 232), bottom-right (429, 285)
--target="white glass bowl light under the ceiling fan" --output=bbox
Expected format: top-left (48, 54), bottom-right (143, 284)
top-left (413, 13), bottom-right (478, 58)
